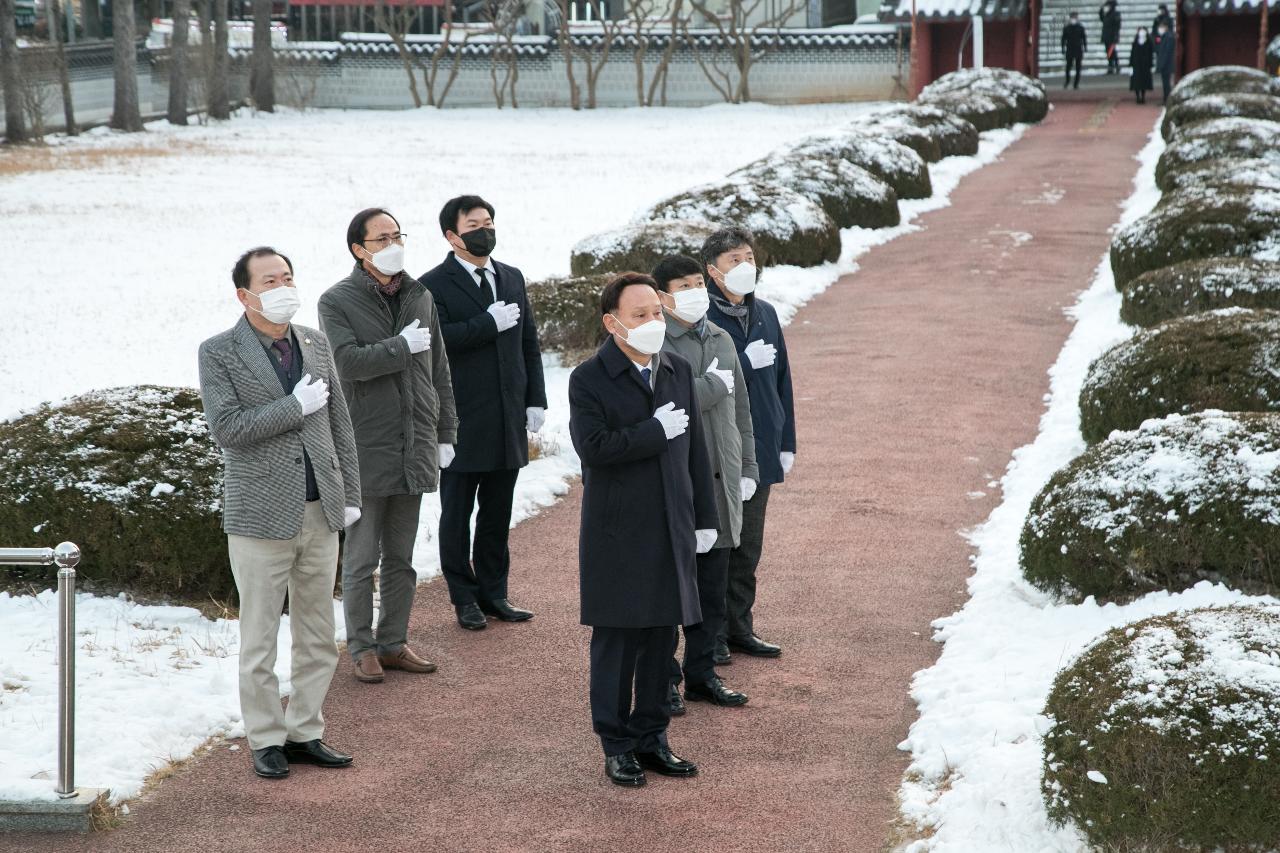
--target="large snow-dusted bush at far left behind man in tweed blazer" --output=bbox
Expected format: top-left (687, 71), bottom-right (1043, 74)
top-left (0, 386), bottom-right (236, 601)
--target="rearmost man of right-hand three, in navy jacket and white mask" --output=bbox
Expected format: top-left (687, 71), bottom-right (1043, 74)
top-left (700, 228), bottom-right (796, 663)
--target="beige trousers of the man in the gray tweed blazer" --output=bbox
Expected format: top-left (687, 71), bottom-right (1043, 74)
top-left (227, 501), bottom-right (338, 749)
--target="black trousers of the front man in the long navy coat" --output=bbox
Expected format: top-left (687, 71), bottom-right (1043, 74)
top-left (591, 626), bottom-right (676, 756)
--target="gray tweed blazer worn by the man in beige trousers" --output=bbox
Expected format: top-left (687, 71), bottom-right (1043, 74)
top-left (200, 316), bottom-right (360, 539)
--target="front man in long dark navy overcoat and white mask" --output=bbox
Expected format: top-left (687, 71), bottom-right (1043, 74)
top-left (568, 273), bottom-right (718, 786)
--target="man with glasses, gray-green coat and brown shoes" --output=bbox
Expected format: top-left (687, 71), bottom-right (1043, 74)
top-left (320, 207), bottom-right (458, 683)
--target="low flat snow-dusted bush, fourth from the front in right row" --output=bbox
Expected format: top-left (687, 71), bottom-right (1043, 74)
top-left (1120, 253), bottom-right (1280, 327)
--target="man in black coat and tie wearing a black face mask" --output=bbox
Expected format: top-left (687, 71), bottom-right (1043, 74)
top-left (420, 196), bottom-right (547, 630)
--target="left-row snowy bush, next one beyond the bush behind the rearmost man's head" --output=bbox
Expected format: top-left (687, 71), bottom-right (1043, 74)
top-left (730, 152), bottom-right (901, 228)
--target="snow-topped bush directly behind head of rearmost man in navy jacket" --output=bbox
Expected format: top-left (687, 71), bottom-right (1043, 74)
top-left (637, 174), bottom-right (839, 266)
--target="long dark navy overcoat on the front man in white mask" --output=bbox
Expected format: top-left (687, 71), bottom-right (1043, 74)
top-left (568, 337), bottom-right (718, 628)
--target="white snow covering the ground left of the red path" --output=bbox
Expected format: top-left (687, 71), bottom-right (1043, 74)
top-left (0, 104), bottom-right (1024, 802)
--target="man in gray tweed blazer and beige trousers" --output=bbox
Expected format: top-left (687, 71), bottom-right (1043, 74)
top-left (200, 247), bottom-right (360, 779)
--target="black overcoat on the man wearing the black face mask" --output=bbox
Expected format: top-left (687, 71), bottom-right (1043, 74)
top-left (419, 252), bottom-right (547, 473)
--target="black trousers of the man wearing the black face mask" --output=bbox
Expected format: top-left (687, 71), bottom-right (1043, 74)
top-left (440, 469), bottom-right (520, 607)
